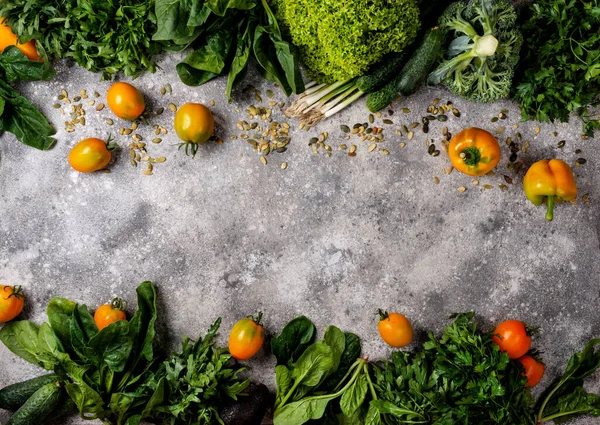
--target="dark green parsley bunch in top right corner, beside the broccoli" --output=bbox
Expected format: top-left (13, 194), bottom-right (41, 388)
top-left (514, 0), bottom-right (600, 136)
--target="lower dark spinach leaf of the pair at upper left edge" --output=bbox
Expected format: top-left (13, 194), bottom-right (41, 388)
top-left (0, 79), bottom-right (55, 150)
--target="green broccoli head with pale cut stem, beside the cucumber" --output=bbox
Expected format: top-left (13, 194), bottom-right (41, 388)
top-left (429, 0), bottom-right (523, 102)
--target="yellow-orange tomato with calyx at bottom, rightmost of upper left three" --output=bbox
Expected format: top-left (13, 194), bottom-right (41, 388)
top-left (174, 103), bottom-right (215, 155)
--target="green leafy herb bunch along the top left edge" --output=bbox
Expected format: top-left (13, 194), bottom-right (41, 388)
top-left (0, 0), bottom-right (163, 79)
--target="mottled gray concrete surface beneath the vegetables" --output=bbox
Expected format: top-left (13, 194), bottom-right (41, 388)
top-left (0, 50), bottom-right (600, 425)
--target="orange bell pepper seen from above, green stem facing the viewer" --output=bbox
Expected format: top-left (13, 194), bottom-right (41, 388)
top-left (448, 127), bottom-right (500, 176)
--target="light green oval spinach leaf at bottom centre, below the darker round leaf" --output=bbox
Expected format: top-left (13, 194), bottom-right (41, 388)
top-left (292, 341), bottom-right (334, 387)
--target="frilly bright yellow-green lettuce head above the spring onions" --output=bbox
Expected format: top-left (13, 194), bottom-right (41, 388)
top-left (276, 0), bottom-right (420, 83)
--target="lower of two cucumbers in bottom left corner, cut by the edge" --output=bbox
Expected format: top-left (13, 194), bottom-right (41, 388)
top-left (6, 383), bottom-right (63, 425)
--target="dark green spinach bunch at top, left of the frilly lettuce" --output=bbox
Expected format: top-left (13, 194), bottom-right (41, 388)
top-left (153, 0), bottom-right (304, 99)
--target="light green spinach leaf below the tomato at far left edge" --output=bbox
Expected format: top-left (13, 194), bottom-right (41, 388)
top-left (0, 320), bottom-right (44, 367)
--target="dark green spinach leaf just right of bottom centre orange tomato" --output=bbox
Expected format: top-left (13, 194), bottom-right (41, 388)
top-left (271, 316), bottom-right (315, 365)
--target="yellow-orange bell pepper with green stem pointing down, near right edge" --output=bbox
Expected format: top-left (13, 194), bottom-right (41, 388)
top-left (523, 159), bottom-right (577, 221)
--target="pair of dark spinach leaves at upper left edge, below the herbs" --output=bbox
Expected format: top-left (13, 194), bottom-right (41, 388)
top-left (0, 46), bottom-right (55, 150)
